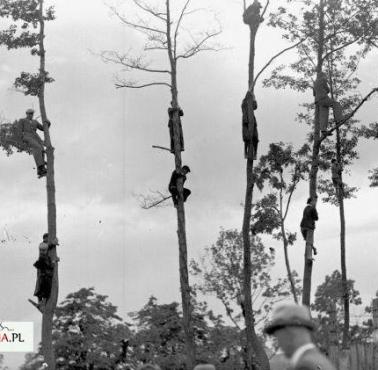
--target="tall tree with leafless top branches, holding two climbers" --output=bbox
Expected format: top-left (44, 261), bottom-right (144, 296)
top-left (102, 0), bottom-right (221, 368)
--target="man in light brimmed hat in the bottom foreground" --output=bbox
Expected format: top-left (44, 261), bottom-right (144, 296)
top-left (264, 303), bottom-right (336, 370)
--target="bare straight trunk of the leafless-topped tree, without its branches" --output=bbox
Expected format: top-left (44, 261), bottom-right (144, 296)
top-left (166, 0), bottom-right (196, 369)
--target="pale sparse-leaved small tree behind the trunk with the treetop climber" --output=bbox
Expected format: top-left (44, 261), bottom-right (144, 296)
top-left (190, 229), bottom-right (289, 327)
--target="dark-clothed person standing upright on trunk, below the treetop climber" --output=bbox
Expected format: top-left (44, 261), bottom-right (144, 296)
top-left (242, 90), bottom-right (259, 159)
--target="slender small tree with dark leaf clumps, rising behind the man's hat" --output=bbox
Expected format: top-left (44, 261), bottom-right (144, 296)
top-left (253, 143), bottom-right (310, 303)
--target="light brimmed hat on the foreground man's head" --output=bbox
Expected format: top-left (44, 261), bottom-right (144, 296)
top-left (264, 303), bottom-right (315, 335)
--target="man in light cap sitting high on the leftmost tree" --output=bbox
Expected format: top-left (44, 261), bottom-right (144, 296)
top-left (18, 109), bottom-right (50, 178)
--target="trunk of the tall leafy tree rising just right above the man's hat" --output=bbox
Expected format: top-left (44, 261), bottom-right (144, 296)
top-left (302, 0), bottom-right (324, 306)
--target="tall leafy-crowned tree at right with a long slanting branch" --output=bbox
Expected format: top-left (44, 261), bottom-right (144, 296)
top-left (265, 0), bottom-right (378, 305)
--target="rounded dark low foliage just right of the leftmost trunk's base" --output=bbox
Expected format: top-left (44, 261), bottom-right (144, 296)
top-left (21, 288), bottom-right (131, 370)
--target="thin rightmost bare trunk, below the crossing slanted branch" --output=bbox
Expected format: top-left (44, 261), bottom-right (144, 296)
top-left (336, 128), bottom-right (350, 348)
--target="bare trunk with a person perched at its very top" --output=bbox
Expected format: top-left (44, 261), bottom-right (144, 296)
top-left (242, 6), bottom-right (269, 370)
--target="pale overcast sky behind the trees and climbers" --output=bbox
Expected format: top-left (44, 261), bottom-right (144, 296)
top-left (0, 0), bottom-right (378, 367)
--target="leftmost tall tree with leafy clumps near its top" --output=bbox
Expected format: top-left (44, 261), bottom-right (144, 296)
top-left (0, 0), bottom-right (59, 369)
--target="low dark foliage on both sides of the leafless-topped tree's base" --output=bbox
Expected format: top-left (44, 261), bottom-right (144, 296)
top-left (130, 297), bottom-right (242, 370)
